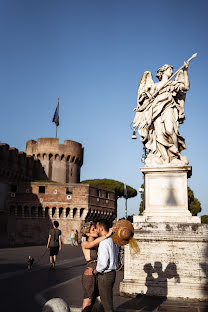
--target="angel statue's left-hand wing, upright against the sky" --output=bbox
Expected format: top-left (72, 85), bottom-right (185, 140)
top-left (137, 71), bottom-right (154, 107)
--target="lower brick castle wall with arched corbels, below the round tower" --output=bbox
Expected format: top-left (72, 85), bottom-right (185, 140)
top-left (7, 182), bottom-right (117, 245)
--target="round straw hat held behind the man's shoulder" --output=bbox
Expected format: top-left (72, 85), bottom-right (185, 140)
top-left (112, 220), bottom-right (134, 246)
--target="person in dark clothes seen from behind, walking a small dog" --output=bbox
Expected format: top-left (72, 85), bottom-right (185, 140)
top-left (47, 221), bottom-right (61, 269)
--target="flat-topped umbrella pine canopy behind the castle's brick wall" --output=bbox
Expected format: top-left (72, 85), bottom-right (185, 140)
top-left (81, 179), bottom-right (137, 198)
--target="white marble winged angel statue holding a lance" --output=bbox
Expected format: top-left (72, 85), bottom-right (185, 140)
top-left (133, 54), bottom-right (197, 167)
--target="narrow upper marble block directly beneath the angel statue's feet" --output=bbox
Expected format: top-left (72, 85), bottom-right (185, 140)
top-left (141, 166), bottom-right (192, 218)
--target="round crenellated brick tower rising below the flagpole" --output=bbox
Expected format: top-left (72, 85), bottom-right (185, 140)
top-left (26, 138), bottom-right (84, 183)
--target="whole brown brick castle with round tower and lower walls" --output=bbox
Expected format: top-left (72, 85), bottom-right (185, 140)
top-left (0, 138), bottom-right (117, 245)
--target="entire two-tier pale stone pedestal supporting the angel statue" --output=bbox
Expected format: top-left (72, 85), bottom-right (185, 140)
top-left (120, 166), bottom-right (208, 300)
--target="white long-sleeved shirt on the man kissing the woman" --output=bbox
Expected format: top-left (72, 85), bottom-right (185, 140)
top-left (96, 237), bottom-right (119, 273)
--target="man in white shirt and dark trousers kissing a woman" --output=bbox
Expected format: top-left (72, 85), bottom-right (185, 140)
top-left (92, 220), bottom-right (118, 312)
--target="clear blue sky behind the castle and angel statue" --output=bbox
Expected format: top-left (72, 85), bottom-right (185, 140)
top-left (0, 0), bottom-right (208, 217)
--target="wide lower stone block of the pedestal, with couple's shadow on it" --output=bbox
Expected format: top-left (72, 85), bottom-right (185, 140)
top-left (120, 216), bottom-right (208, 300)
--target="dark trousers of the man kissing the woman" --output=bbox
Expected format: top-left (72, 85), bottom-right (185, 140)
top-left (98, 271), bottom-right (116, 312)
